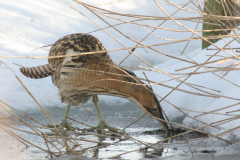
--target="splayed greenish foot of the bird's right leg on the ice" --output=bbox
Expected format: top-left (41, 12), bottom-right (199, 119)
top-left (81, 121), bottom-right (118, 133)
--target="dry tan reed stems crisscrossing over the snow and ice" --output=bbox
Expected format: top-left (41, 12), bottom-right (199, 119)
top-left (0, 0), bottom-right (240, 159)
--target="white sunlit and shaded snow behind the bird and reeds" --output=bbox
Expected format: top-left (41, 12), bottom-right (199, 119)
top-left (0, 0), bottom-right (240, 141)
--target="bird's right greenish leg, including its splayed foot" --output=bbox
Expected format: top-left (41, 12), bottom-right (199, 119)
top-left (83, 95), bottom-right (118, 132)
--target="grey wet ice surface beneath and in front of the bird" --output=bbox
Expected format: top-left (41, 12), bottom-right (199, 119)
top-left (6, 101), bottom-right (240, 160)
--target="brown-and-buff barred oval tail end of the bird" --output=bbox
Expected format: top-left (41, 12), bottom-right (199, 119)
top-left (20, 64), bottom-right (56, 79)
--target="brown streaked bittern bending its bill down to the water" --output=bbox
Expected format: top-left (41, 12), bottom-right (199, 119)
top-left (20, 33), bottom-right (170, 135)
